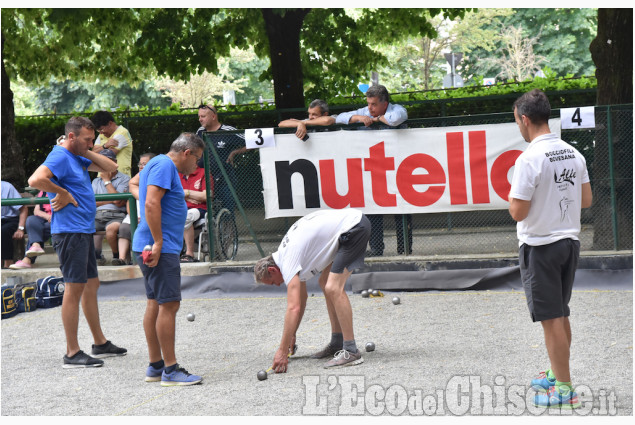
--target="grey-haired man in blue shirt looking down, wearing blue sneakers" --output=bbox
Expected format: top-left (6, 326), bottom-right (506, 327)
top-left (130, 133), bottom-right (205, 386)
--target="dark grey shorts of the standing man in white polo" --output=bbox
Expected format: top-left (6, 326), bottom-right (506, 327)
top-left (518, 239), bottom-right (580, 322)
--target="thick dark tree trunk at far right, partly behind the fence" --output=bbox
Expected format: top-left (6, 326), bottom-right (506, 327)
top-left (589, 9), bottom-right (633, 250)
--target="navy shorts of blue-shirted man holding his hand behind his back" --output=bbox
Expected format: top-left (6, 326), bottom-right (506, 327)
top-left (133, 252), bottom-right (181, 304)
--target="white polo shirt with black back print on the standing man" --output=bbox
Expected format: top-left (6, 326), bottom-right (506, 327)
top-left (510, 133), bottom-right (589, 246)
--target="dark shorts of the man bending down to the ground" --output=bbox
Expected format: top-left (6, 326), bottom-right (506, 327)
top-left (331, 214), bottom-right (370, 273)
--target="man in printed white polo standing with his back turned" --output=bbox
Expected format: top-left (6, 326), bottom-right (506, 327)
top-left (509, 89), bottom-right (593, 408)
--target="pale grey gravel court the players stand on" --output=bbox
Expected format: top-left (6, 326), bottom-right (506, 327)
top-left (2, 291), bottom-right (633, 416)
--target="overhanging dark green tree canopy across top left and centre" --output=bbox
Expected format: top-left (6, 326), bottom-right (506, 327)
top-left (2, 8), bottom-right (472, 106)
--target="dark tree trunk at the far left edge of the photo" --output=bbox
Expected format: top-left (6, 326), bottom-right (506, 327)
top-left (0, 38), bottom-right (26, 191)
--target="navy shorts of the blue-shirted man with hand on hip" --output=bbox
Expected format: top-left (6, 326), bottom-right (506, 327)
top-left (51, 233), bottom-right (98, 283)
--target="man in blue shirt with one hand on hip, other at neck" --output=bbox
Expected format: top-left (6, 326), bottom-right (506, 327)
top-left (29, 117), bottom-right (127, 369)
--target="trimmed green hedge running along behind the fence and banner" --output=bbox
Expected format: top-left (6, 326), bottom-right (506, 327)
top-left (15, 78), bottom-right (596, 179)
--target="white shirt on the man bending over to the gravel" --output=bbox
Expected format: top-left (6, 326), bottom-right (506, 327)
top-left (272, 209), bottom-right (362, 284)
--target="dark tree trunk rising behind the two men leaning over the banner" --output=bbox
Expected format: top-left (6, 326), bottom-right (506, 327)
top-left (261, 9), bottom-right (310, 114)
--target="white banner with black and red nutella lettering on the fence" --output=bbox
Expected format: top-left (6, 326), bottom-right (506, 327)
top-left (260, 119), bottom-right (560, 218)
